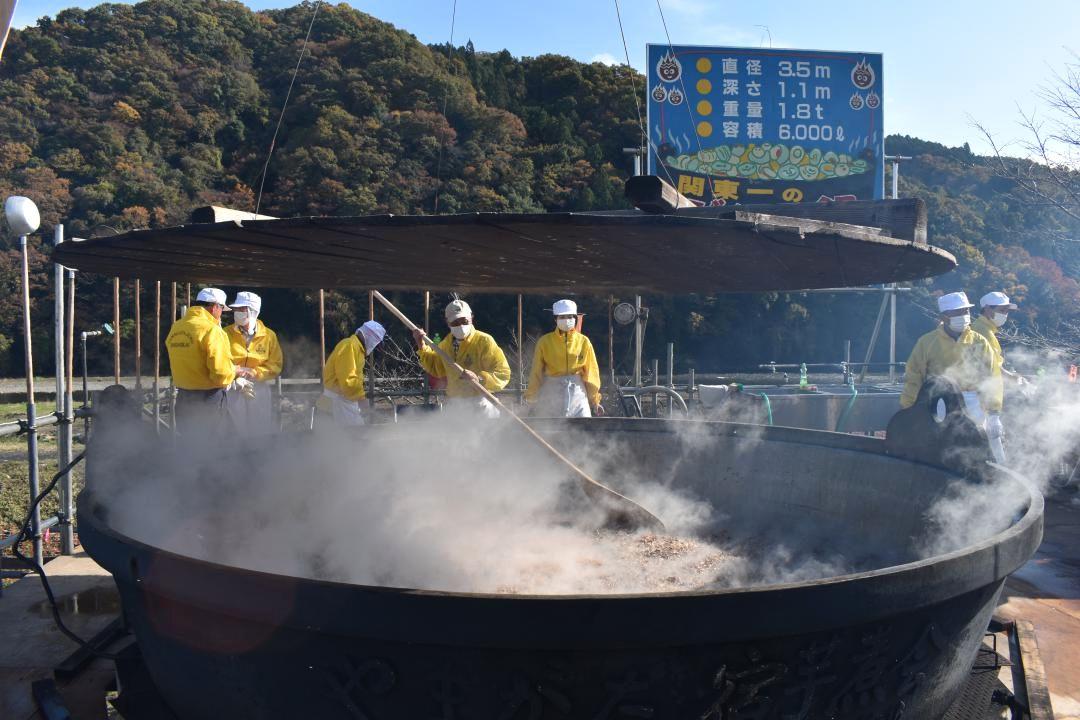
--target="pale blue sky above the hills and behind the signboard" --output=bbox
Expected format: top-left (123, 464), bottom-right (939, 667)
top-left (14, 0), bottom-right (1080, 154)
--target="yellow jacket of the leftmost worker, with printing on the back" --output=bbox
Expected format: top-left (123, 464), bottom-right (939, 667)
top-left (165, 305), bottom-right (235, 390)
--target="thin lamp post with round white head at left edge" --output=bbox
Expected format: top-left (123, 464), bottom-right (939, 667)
top-left (3, 195), bottom-right (43, 565)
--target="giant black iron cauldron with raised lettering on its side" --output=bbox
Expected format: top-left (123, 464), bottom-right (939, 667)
top-left (79, 419), bottom-right (1043, 720)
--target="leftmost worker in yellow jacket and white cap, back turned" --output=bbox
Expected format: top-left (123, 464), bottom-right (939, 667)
top-left (165, 287), bottom-right (237, 434)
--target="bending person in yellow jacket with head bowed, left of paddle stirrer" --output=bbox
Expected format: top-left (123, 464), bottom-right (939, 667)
top-left (320, 320), bottom-right (387, 427)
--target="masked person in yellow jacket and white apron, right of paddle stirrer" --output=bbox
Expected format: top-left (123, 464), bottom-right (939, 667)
top-left (525, 300), bottom-right (604, 418)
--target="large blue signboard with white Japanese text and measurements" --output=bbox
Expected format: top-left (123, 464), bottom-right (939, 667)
top-left (648, 44), bottom-right (885, 205)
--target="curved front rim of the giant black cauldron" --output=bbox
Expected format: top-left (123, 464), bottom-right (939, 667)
top-left (79, 463), bottom-right (1043, 603)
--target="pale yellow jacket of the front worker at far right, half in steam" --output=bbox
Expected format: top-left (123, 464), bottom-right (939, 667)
top-left (900, 325), bottom-right (1001, 412)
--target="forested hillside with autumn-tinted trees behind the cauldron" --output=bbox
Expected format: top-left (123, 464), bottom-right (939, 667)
top-left (0, 0), bottom-right (1080, 375)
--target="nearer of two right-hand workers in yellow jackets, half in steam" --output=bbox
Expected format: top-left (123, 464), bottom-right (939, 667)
top-left (900, 293), bottom-right (1001, 423)
